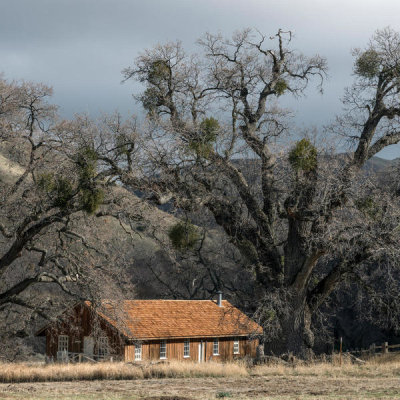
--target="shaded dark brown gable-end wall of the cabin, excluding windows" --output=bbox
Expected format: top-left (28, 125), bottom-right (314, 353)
top-left (45, 304), bottom-right (125, 358)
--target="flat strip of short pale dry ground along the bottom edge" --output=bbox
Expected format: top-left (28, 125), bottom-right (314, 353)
top-left (0, 375), bottom-right (400, 400)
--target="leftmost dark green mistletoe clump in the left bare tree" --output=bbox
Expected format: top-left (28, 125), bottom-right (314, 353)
top-left (37, 173), bottom-right (74, 209)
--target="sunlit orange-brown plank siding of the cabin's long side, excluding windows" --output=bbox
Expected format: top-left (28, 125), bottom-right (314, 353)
top-left (125, 337), bottom-right (258, 362)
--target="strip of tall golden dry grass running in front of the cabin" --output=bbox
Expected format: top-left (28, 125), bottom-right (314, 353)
top-left (0, 354), bottom-right (400, 383)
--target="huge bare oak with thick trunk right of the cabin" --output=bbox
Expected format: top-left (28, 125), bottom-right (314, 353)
top-left (108, 29), bottom-right (400, 356)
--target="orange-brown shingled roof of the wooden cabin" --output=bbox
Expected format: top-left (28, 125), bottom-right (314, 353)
top-left (85, 300), bottom-right (262, 340)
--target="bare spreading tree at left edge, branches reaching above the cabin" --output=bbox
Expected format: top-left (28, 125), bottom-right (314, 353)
top-left (0, 79), bottom-right (140, 333)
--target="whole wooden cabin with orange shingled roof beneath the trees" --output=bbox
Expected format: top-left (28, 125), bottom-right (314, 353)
top-left (37, 299), bottom-right (262, 362)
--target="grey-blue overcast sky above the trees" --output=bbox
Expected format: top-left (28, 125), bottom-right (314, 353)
top-left (0, 0), bottom-right (400, 158)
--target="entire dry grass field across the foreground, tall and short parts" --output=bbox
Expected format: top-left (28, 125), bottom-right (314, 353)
top-left (0, 355), bottom-right (400, 400)
